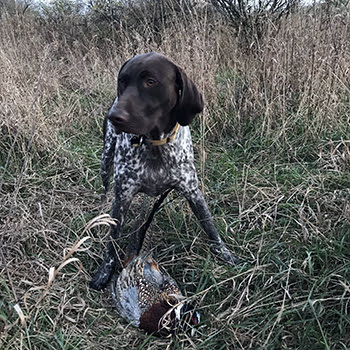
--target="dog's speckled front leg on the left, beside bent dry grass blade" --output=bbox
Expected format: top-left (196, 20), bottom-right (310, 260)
top-left (90, 186), bottom-right (136, 290)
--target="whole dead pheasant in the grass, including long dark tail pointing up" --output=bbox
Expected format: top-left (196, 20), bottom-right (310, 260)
top-left (111, 194), bottom-right (200, 336)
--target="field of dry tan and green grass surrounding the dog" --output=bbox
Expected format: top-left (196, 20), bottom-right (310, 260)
top-left (0, 1), bottom-right (350, 350)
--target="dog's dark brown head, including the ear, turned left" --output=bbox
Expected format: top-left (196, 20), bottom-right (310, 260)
top-left (107, 52), bottom-right (203, 138)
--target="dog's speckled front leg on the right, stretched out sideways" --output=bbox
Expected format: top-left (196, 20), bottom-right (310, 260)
top-left (183, 188), bottom-right (240, 265)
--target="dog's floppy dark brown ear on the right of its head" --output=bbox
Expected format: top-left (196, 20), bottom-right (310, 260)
top-left (173, 66), bottom-right (204, 126)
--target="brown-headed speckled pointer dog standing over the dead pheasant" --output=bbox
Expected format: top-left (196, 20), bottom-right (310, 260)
top-left (90, 52), bottom-right (239, 290)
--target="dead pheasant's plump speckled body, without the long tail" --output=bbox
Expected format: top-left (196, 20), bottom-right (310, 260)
top-left (111, 256), bottom-right (190, 332)
